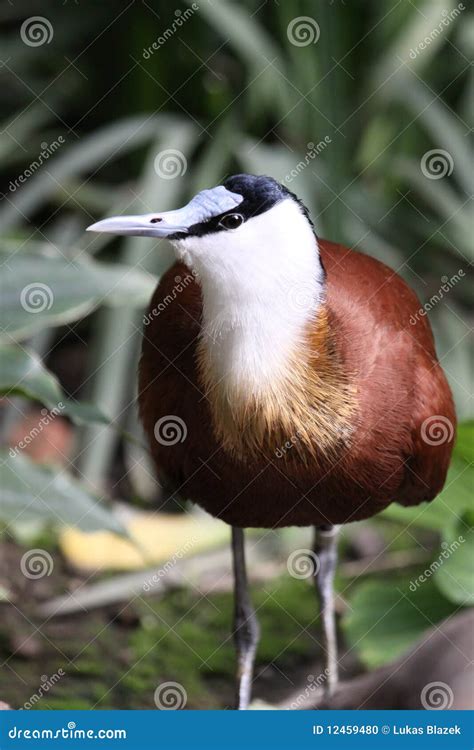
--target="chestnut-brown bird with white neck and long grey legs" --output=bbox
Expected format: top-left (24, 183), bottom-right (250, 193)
top-left (88, 174), bottom-right (456, 710)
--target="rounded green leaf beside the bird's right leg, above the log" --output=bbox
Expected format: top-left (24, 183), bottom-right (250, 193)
top-left (343, 578), bottom-right (456, 669)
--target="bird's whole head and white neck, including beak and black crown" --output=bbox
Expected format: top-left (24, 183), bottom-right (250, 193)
top-left (88, 174), bottom-right (325, 408)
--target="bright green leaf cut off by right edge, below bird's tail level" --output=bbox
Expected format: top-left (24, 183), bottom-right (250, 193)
top-left (434, 523), bottom-right (474, 604)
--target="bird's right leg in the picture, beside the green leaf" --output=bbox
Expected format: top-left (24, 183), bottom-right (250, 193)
top-left (314, 524), bottom-right (339, 698)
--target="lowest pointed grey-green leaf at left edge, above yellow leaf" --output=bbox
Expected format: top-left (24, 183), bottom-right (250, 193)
top-left (0, 451), bottom-right (126, 534)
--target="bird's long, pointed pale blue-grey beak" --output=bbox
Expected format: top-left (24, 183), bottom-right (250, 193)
top-left (86, 206), bottom-right (195, 238)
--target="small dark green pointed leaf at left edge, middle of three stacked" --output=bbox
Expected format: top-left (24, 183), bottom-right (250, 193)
top-left (0, 344), bottom-right (110, 424)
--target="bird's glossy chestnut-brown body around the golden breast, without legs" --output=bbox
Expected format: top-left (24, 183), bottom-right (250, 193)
top-left (139, 240), bottom-right (455, 528)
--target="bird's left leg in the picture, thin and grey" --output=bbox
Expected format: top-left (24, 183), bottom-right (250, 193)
top-left (232, 526), bottom-right (260, 710)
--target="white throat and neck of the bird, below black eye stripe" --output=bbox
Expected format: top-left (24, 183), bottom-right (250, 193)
top-left (176, 198), bottom-right (324, 398)
